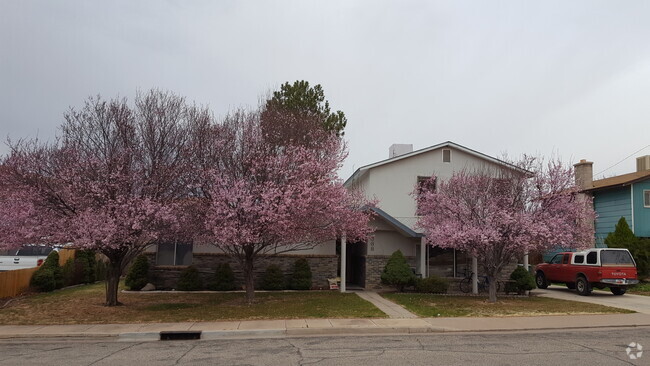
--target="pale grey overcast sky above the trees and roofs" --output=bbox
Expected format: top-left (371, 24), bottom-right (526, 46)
top-left (0, 0), bottom-right (650, 178)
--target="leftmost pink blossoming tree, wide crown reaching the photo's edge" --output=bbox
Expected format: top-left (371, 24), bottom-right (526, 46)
top-left (0, 91), bottom-right (206, 306)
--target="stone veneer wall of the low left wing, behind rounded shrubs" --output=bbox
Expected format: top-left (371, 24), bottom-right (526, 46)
top-left (147, 253), bottom-right (336, 289)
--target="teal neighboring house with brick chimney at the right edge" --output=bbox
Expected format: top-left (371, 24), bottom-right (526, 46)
top-left (574, 155), bottom-right (650, 247)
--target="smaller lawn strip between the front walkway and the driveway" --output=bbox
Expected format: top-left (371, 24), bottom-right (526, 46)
top-left (383, 293), bottom-right (633, 317)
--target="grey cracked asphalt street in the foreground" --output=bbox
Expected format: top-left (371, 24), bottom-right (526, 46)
top-left (0, 327), bottom-right (650, 366)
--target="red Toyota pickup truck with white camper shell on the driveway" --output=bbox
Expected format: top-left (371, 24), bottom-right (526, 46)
top-left (535, 248), bottom-right (639, 295)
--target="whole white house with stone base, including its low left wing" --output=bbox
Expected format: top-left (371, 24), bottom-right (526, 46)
top-left (146, 141), bottom-right (517, 288)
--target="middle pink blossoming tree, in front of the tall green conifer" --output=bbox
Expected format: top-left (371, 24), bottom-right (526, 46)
top-left (200, 112), bottom-right (370, 302)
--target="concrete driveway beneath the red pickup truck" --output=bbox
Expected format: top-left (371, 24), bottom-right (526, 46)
top-left (531, 286), bottom-right (650, 314)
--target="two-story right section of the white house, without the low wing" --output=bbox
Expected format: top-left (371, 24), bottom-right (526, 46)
top-left (345, 141), bottom-right (517, 288)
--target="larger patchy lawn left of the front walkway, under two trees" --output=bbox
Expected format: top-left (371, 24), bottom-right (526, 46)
top-left (0, 284), bottom-right (386, 324)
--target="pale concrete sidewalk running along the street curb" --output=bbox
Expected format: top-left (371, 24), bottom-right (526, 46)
top-left (0, 313), bottom-right (650, 341)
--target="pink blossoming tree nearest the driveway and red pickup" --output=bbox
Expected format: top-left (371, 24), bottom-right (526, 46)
top-left (417, 158), bottom-right (595, 302)
